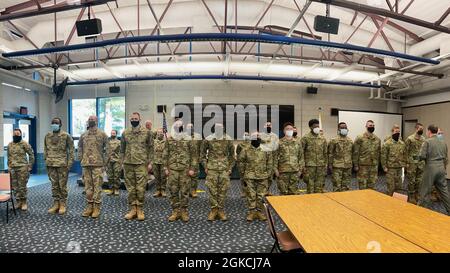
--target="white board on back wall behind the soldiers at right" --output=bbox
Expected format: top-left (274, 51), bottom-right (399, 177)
top-left (338, 110), bottom-right (403, 142)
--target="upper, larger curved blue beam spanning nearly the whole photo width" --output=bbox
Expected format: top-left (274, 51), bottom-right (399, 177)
top-left (2, 33), bottom-right (439, 64)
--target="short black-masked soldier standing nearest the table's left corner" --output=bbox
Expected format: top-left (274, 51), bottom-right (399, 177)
top-left (238, 132), bottom-right (274, 221)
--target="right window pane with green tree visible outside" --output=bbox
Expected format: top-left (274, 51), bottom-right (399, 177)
top-left (98, 97), bottom-right (125, 136)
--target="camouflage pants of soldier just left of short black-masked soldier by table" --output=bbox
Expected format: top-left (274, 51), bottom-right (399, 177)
top-left (205, 170), bottom-right (230, 209)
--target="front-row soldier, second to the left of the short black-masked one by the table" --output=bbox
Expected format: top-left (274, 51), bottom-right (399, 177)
top-left (163, 120), bottom-right (198, 222)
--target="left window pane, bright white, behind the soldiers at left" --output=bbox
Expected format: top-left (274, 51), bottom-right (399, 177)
top-left (71, 99), bottom-right (96, 137)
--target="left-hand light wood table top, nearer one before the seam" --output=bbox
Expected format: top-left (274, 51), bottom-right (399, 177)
top-left (267, 194), bottom-right (427, 253)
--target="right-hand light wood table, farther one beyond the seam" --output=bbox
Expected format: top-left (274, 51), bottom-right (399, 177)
top-left (324, 190), bottom-right (450, 253)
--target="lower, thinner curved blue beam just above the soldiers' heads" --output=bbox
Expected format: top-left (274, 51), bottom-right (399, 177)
top-left (67, 75), bottom-right (381, 88)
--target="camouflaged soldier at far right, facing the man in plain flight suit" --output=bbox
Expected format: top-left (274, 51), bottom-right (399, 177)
top-left (405, 123), bottom-right (425, 204)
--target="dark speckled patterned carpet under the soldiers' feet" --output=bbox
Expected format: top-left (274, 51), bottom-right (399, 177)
top-left (0, 173), bottom-right (443, 253)
